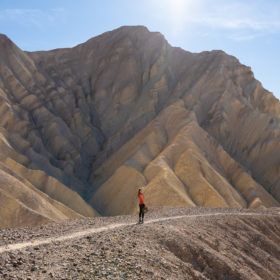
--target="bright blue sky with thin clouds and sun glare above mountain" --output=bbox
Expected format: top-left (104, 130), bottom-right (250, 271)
top-left (0, 0), bottom-right (280, 99)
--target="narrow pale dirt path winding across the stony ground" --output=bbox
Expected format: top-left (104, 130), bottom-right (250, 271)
top-left (0, 213), bottom-right (280, 254)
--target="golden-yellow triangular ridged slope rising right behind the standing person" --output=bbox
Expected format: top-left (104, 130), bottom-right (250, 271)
top-left (92, 102), bottom-right (279, 214)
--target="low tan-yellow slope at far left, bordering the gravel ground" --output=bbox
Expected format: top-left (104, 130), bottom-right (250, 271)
top-left (0, 165), bottom-right (81, 227)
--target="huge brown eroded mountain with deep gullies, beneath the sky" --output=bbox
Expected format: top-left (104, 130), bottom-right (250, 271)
top-left (0, 27), bottom-right (280, 225)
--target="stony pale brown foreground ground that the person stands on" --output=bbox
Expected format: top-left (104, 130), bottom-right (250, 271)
top-left (0, 208), bottom-right (280, 280)
